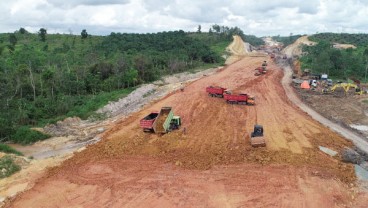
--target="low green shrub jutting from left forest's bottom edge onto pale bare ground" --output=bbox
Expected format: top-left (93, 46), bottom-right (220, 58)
top-left (11, 126), bottom-right (50, 144)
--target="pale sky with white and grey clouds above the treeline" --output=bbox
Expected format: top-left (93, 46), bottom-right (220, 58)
top-left (0, 0), bottom-right (368, 36)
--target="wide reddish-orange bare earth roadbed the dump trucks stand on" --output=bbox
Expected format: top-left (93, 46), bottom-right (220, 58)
top-left (6, 37), bottom-right (368, 207)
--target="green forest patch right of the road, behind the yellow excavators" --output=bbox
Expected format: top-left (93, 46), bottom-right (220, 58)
top-left (300, 33), bottom-right (368, 82)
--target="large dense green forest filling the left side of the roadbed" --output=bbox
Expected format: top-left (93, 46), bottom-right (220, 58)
top-left (0, 25), bottom-right (260, 143)
